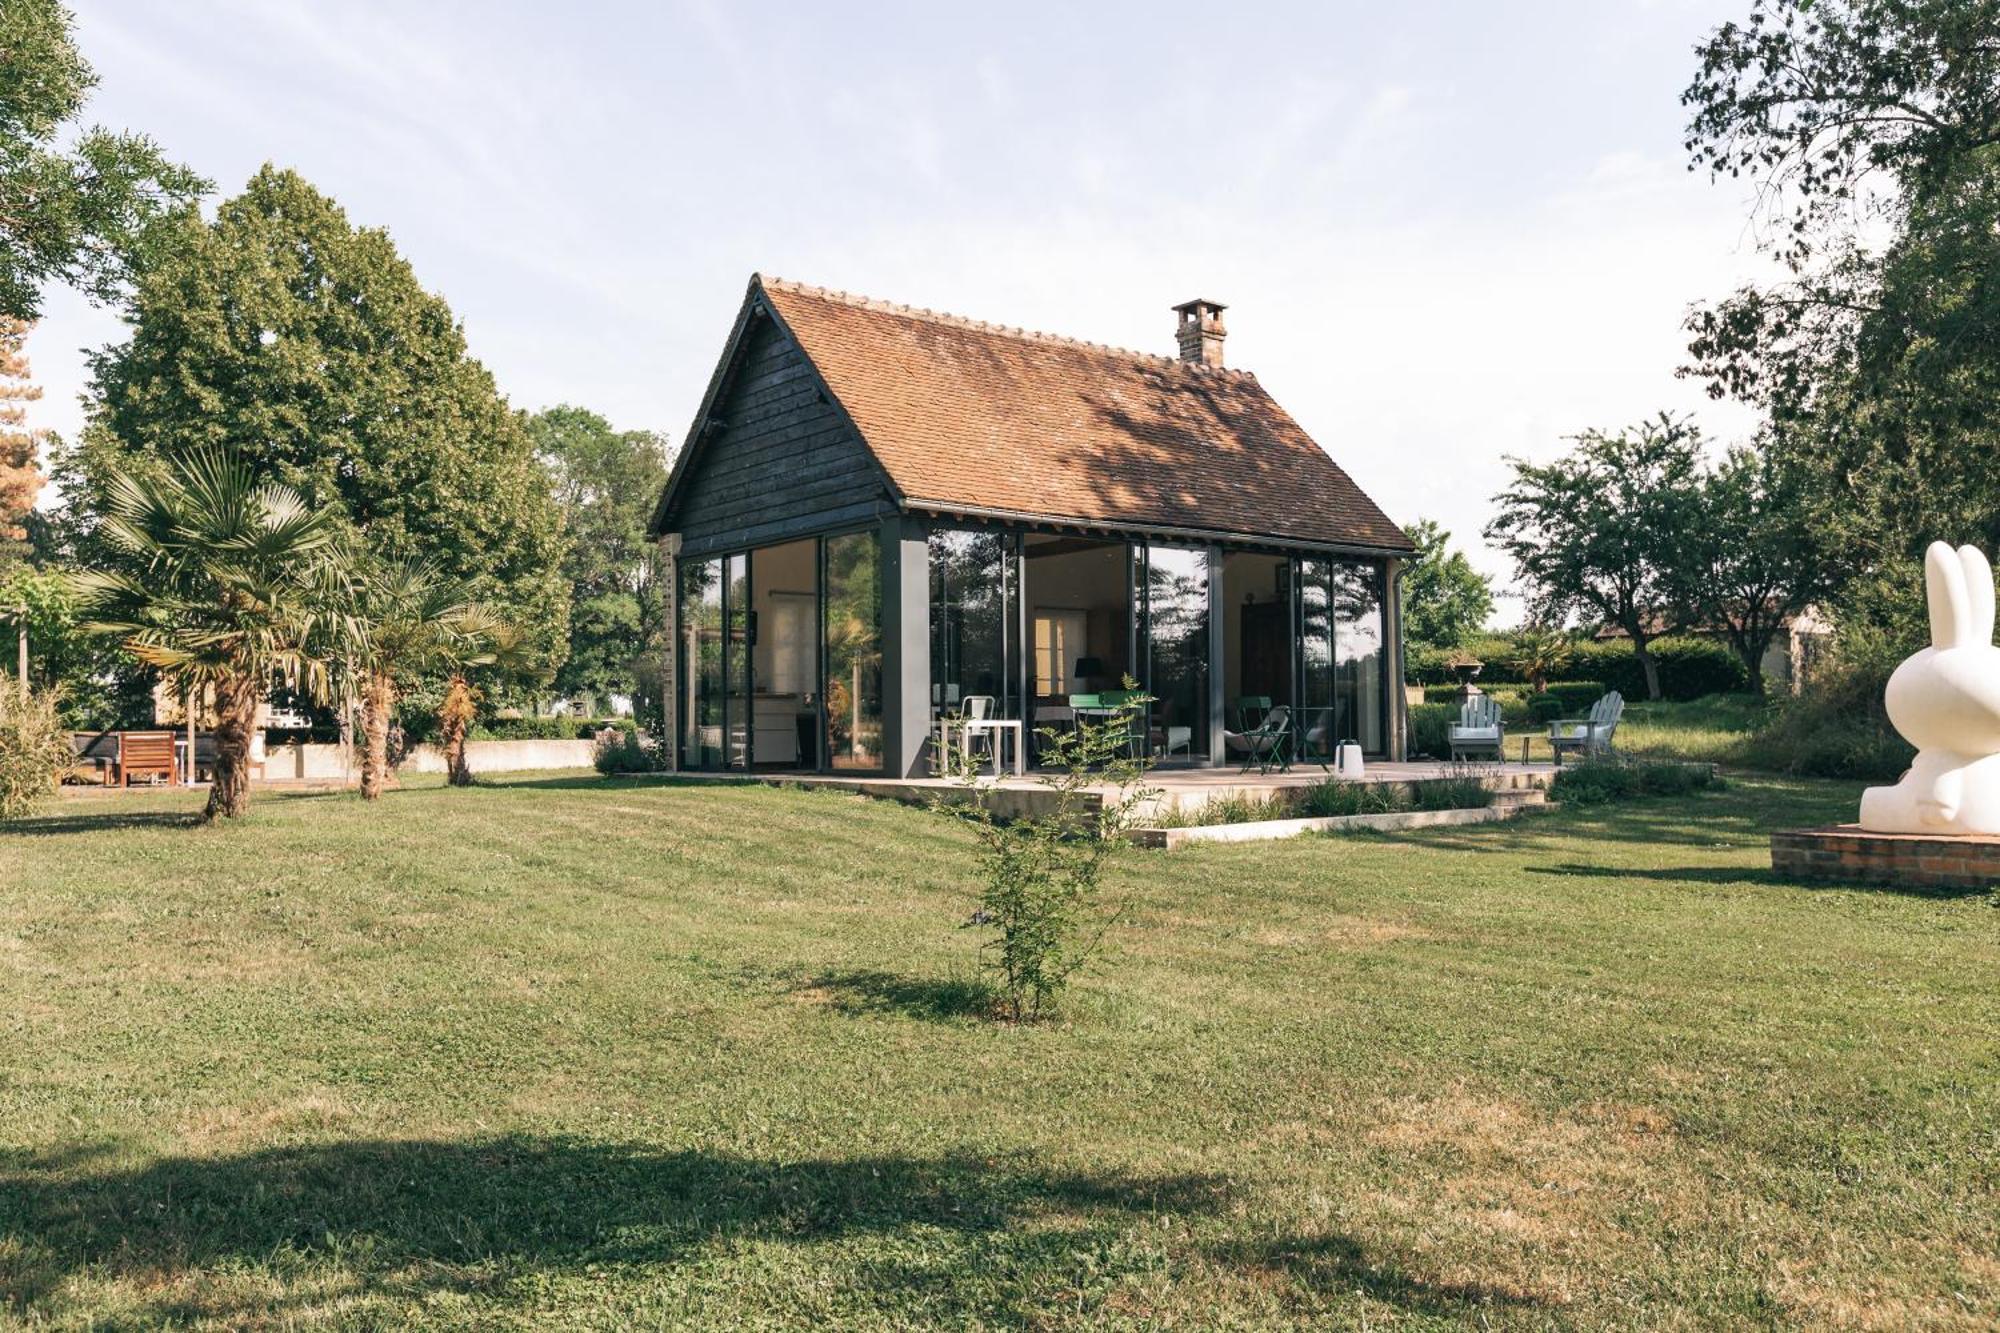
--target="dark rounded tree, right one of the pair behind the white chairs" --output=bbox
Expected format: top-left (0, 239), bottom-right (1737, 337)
top-left (1680, 448), bottom-right (1826, 695)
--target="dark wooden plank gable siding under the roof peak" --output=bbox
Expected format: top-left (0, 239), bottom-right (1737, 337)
top-left (670, 318), bottom-right (896, 556)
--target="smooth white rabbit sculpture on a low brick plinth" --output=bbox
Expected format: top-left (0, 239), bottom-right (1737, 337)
top-left (1862, 542), bottom-right (2000, 835)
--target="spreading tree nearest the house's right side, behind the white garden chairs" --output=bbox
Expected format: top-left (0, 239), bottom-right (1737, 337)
top-left (1486, 412), bottom-right (1702, 699)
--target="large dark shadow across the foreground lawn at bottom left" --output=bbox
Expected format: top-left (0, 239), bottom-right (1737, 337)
top-left (0, 1135), bottom-right (1228, 1323)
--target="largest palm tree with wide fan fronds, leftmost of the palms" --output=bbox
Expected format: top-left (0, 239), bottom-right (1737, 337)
top-left (74, 448), bottom-right (344, 821)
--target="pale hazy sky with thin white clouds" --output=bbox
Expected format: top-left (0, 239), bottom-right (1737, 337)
top-left (28, 0), bottom-right (1764, 620)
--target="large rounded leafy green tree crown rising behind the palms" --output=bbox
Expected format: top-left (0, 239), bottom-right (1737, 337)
top-left (82, 166), bottom-right (568, 667)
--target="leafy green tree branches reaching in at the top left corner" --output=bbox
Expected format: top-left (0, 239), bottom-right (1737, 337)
top-left (0, 0), bottom-right (208, 320)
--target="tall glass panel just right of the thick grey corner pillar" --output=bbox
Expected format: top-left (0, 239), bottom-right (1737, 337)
top-left (930, 528), bottom-right (1020, 719)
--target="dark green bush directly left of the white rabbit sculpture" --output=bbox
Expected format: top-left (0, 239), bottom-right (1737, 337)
top-left (1744, 654), bottom-right (1916, 779)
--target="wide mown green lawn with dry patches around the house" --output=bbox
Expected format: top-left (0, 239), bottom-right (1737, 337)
top-left (0, 777), bottom-right (2000, 1329)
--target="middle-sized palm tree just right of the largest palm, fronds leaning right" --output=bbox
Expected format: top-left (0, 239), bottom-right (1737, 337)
top-left (350, 558), bottom-right (506, 801)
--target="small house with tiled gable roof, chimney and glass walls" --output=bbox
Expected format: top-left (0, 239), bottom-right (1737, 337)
top-left (652, 276), bottom-right (1412, 777)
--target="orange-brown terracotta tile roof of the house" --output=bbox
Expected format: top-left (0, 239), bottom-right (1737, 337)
top-left (758, 278), bottom-right (1410, 550)
